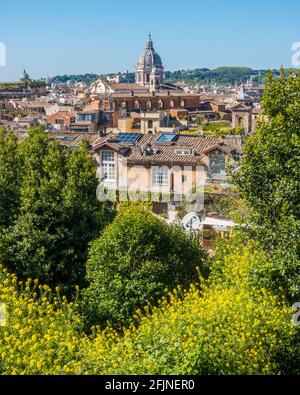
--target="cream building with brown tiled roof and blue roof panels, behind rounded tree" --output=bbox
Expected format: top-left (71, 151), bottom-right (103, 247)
top-left (93, 133), bottom-right (240, 204)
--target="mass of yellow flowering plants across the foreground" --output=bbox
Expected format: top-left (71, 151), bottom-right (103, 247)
top-left (0, 244), bottom-right (300, 375)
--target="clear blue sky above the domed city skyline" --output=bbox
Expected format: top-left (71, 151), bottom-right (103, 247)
top-left (0, 0), bottom-right (300, 81)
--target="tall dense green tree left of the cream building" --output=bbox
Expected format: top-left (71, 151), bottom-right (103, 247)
top-left (0, 128), bottom-right (109, 287)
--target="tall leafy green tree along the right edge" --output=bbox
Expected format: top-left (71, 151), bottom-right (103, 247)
top-left (234, 71), bottom-right (300, 300)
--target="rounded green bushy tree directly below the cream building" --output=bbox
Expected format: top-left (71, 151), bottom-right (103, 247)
top-left (83, 207), bottom-right (204, 326)
